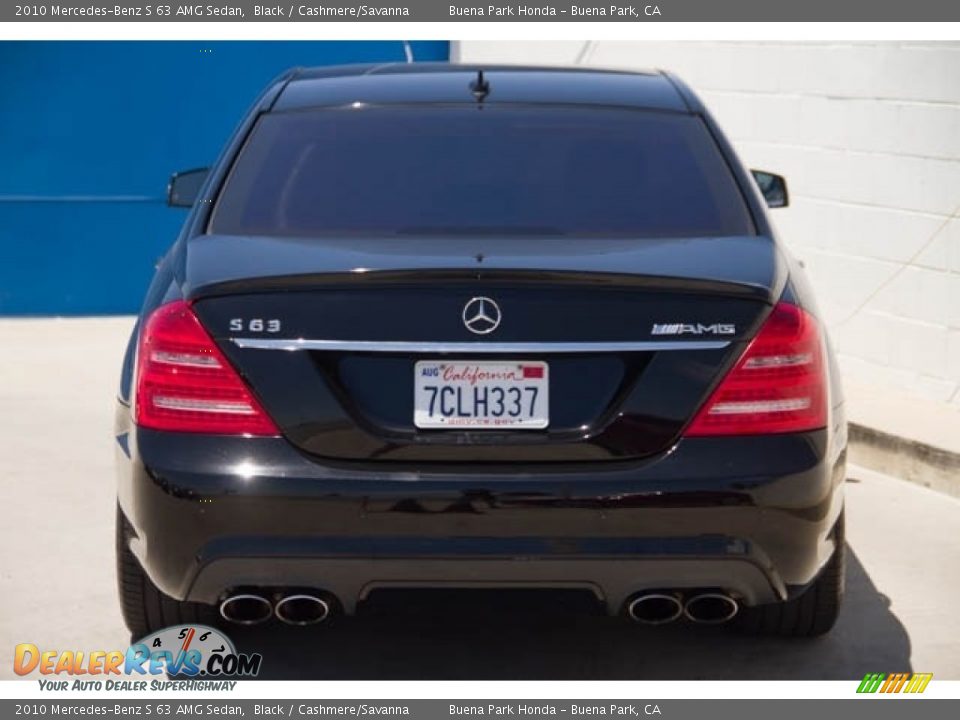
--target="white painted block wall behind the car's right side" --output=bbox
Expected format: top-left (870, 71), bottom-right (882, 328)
top-left (453, 41), bottom-right (960, 404)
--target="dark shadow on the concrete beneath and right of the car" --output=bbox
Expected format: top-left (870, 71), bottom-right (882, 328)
top-left (223, 547), bottom-right (912, 680)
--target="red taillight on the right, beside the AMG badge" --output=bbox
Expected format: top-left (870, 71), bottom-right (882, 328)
top-left (684, 302), bottom-right (827, 436)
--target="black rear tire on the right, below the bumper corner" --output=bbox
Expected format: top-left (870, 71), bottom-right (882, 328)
top-left (737, 513), bottom-right (846, 637)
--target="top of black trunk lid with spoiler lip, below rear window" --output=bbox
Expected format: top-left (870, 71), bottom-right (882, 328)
top-left (177, 235), bottom-right (787, 304)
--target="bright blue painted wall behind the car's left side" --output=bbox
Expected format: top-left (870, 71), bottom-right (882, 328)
top-left (0, 41), bottom-right (449, 315)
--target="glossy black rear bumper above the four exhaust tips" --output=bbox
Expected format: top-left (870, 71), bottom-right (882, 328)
top-left (117, 429), bottom-right (844, 613)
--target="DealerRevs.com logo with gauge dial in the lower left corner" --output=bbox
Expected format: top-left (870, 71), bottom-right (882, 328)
top-left (13, 625), bottom-right (263, 690)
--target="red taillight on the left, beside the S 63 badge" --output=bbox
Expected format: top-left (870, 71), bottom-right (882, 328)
top-left (136, 300), bottom-right (280, 435)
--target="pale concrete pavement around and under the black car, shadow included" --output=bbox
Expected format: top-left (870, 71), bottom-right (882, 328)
top-left (0, 318), bottom-right (960, 679)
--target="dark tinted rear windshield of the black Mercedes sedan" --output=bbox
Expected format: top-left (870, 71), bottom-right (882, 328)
top-left (210, 105), bottom-right (753, 237)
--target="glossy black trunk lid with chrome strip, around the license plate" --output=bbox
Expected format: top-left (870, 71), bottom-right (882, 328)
top-left (180, 236), bottom-right (784, 465)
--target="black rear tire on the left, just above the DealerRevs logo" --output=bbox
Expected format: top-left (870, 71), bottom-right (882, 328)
top-left (116, 505), bottom-right (218, 640)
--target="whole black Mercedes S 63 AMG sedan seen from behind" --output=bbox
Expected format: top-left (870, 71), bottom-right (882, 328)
top-left (116, 64), bottom-right (846, 635)
